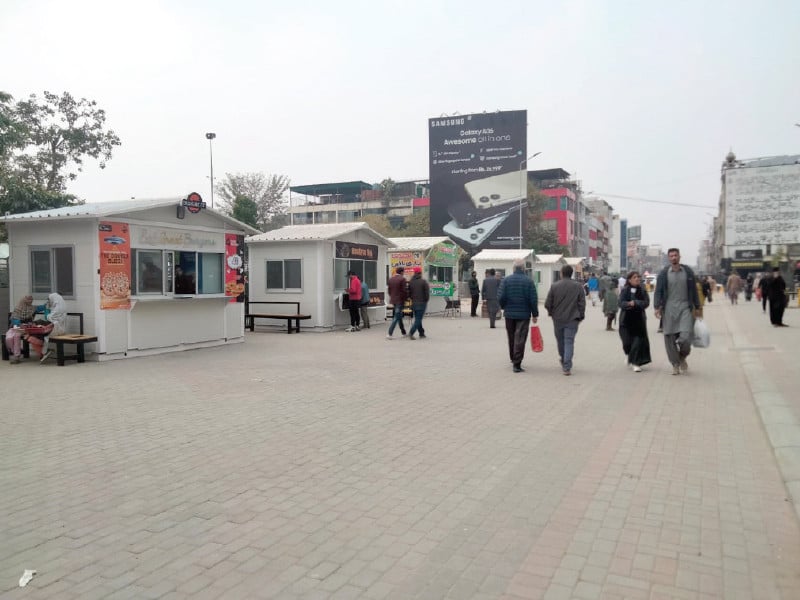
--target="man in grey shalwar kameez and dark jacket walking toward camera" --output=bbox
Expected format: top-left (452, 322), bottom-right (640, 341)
top-left (653, 248), bottom-right (700, 375)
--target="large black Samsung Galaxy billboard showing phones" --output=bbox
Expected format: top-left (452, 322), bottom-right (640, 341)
top-left (428, 110), bottom-right (528, 251)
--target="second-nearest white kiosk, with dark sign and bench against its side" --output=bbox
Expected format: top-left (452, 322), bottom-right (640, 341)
top-left (245, 222), bottom-right (393, 330)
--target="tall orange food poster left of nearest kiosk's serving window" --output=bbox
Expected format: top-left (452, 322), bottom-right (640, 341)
top-left (98, 221), bottom-right (131, 310)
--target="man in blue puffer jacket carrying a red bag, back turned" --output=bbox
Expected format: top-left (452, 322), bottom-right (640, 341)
top-left (497, 259), bottom-right (539, 373)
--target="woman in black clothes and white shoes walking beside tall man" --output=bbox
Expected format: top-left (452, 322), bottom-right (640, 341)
top-left (619, 271), bottom-right (650, 373)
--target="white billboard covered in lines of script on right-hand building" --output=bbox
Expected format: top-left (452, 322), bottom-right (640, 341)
top-left (725, 164), bottom-right (800, 246)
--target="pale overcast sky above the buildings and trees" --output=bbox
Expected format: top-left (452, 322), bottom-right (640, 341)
top-left (0, 0), bottom-right (800, 264)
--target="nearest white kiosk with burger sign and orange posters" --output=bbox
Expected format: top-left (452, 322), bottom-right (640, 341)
top-left (0, 196), bottom-right (257, 360)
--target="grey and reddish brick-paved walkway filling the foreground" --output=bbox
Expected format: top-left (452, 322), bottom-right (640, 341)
top-left (0, 297), bottom-right (800, 600)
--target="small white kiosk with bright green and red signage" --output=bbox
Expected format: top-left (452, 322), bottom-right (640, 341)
top-left (388, 236), bottom-right (462, 313)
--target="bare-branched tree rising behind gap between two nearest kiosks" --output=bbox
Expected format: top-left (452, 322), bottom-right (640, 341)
top-left (215, 173), bottom-right (289, 230)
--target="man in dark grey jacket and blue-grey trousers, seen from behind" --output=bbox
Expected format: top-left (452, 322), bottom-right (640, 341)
top-left (544, 265), bottom-right (586, 375)
